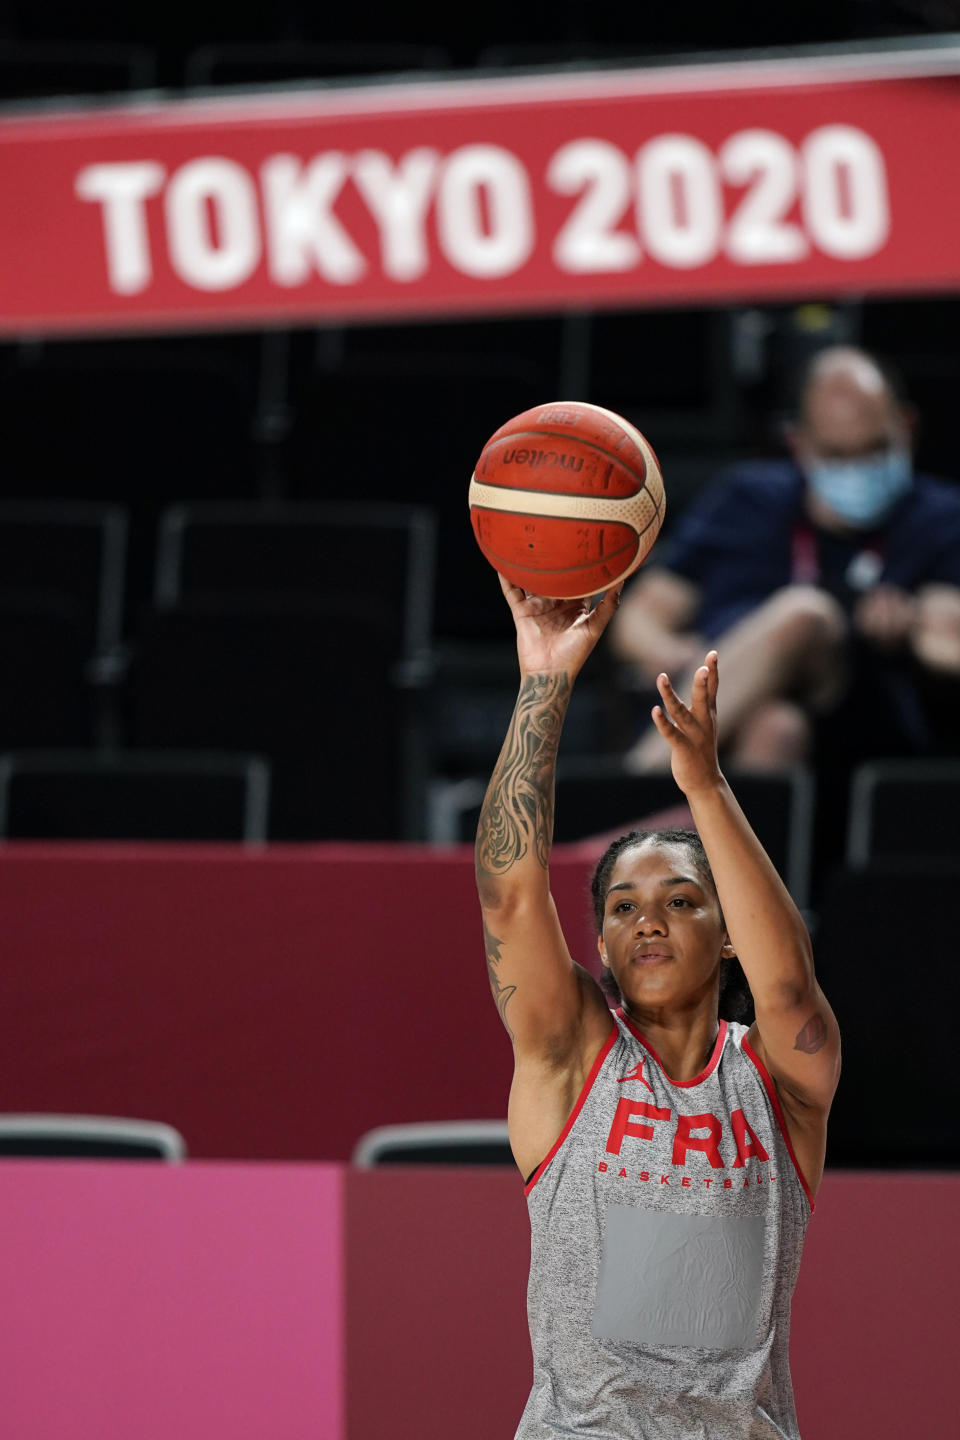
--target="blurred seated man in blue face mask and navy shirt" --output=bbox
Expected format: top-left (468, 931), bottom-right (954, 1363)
top-left (610, 346), bottom-right (960, 770)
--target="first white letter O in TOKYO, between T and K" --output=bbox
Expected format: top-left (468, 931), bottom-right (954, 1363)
top-left (164, 156), bottom-right (261, 289)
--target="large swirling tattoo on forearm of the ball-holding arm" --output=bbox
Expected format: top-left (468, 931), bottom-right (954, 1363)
top-left (476, 674), bottom-right (570, 896)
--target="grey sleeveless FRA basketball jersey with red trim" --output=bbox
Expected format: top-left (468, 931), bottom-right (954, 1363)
top-left (517, 1011), bottom-right (813, 1440)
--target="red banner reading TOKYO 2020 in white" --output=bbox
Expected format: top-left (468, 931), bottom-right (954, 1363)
top-left (0, 50), bottom-right (960, 334)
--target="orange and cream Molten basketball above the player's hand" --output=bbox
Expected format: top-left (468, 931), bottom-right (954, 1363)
top-left (469, 400), bottom-right (666, 599)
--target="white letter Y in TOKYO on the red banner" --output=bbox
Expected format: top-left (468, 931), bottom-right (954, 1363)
top-left (353, 148), bottom-right (439, 281)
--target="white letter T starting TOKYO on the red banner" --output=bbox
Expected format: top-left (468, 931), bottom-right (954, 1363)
top-left (73, 160), bottom-right (166, 295)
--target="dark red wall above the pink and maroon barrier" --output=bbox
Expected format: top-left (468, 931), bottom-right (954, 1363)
top-left (0, 845), bottom-right (596, 1161)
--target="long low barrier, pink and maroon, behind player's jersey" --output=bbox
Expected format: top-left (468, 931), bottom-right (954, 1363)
top-left (0, 1161), bottom-right (960, 1440)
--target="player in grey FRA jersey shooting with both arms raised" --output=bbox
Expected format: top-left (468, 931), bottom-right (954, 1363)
top-left (476, 577), bottom-right (841, 1440)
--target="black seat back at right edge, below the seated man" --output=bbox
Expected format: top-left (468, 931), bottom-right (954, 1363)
top-left (846, 759), bottom-right (960, 865)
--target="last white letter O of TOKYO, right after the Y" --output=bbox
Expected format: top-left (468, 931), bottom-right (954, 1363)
top-left (436, 145), bottom-right (534, 279)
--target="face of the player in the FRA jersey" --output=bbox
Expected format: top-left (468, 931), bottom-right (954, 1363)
top-left (597, 842), bottom-right (734, 1009)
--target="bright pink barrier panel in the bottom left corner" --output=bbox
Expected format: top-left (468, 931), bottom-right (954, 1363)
top-left (0, 1161), bottom-right (344, 1440)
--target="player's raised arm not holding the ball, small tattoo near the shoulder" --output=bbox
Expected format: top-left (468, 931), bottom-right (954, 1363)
top-left (653, 651), bottom-right (841, 1112)
